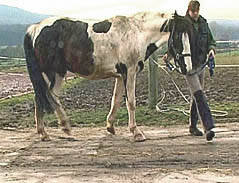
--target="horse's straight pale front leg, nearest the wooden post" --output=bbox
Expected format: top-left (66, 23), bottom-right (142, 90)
top-left (126, 68), bottom-right (146, 142)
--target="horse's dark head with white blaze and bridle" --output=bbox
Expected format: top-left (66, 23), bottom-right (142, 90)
top-left (160, 12), bottom-right (194, 74)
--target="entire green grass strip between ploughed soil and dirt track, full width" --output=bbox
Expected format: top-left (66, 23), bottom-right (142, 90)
top-left (0, 90), bottom-right (236, 127)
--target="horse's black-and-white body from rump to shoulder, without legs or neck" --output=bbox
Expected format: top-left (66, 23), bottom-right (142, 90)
top-left (27, 16), bottom-right (145, 79)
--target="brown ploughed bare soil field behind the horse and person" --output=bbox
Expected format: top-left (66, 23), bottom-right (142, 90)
top-left (0, 67), bottom-right (239, 106)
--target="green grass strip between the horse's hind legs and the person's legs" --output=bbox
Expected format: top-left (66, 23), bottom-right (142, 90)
top-left (59, 106), bottom-right (188, 126)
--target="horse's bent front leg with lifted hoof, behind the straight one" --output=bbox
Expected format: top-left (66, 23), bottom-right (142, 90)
top-left (107, 77), bottom-right (124, 134)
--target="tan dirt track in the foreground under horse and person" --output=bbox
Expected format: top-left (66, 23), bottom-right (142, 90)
top-left (0, 123), bottom-right (239, 183)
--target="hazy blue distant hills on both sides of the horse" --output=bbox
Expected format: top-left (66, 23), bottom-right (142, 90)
top-left (0, 5), bottom-right (239, 46)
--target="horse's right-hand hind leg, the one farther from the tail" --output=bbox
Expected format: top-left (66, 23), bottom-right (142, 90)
top-left (51, 73), bottom-right (71, 135)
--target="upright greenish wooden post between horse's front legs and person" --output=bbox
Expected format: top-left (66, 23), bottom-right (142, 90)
top-left (148, 54), bottom-right (159, 109)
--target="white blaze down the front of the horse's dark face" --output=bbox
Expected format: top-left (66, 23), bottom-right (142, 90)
top-left (182, 32), bottom-right (192, 72)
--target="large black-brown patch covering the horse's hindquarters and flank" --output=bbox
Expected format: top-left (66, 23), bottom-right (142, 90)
top-left (35, 19), bottom-right (94, 77)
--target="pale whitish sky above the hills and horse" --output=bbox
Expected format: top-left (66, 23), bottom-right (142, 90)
top-left (0, 0), bottom-right (239, 20)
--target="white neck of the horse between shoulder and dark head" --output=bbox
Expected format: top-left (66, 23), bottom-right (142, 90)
top-left (143, 18), bottom-right (169, 46)
